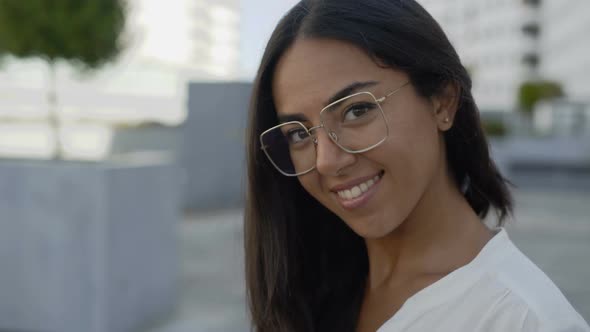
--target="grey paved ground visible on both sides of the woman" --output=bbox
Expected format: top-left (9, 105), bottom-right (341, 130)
top-left (145, 190), bottom-right (590, 332)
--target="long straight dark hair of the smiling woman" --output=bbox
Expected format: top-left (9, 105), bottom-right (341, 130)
top-left (244, 0), bottom-right (512, 332)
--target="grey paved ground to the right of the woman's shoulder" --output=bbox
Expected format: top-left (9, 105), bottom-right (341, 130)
top-left (508, 191), bottom-right (590, 322)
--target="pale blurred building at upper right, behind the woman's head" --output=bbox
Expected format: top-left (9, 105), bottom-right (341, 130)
top-left (419, 0), bottom-right (590, 111)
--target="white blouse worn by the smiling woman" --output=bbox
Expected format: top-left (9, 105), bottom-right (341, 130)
top-left (377, 228), bottom-right (590, 332)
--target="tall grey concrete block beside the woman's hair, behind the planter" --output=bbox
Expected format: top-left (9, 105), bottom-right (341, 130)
top-left (180, 83), bottom-right (252, 210)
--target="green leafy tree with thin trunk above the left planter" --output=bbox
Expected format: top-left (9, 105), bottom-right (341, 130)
top-left (0, 0), bottom-right (126, 157)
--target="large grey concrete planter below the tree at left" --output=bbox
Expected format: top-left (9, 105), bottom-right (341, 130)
top-left (0, 158), bottom-right (180, 332)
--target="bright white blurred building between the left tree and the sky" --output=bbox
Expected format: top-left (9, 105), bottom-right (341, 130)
top-left (135, 0), bottom-right (240, 80)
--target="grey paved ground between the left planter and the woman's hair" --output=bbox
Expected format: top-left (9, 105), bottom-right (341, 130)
top-left (146, 210), bottom-right (248, 332)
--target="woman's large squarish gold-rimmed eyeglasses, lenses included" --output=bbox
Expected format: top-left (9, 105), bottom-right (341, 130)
top-left (260, 82), bottom-right (410, 176)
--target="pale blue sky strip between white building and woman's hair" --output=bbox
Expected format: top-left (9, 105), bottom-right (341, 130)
top-left (240, 0), bottom-right (298, 77)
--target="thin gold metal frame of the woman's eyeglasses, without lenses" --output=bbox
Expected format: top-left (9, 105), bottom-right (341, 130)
top-left (259, 81), bottom-right (410, 177)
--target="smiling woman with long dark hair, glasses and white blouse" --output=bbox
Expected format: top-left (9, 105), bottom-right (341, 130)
top-left (245, 0), bottom-right (588, 332)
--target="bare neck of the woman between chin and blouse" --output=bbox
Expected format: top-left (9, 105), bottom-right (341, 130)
top-left (365, 168), bottom-right (492, 289)
